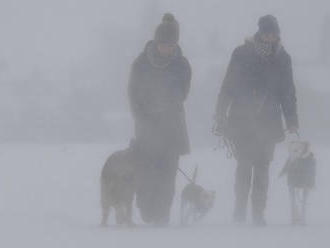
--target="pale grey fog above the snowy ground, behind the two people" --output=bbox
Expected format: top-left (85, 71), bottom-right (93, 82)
top-left (1, 0), bottom-right (329, 145)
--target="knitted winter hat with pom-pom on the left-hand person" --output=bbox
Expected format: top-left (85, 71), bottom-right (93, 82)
top-left (154, 13), bottom-right (180, 44)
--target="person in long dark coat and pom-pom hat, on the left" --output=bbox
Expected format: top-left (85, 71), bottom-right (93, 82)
top-left (129, 14), bottom-right (191, 225)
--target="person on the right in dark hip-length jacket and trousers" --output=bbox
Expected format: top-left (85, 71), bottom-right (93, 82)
top-left (215, 15), bottom-right (298, 225)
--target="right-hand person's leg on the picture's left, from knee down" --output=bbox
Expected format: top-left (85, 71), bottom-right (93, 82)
top-left (234, 161), bottom-right (252, 222)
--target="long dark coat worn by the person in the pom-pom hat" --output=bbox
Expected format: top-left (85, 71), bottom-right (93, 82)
top-left (129, 41), bottom-right (191, 155)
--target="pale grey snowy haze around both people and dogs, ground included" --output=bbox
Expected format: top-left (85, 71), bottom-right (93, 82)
top-left (0, 0), bottom-right (330, 248)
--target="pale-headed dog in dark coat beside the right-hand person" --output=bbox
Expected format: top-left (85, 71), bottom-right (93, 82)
top-left (280, 141), bottom-right (316, 225)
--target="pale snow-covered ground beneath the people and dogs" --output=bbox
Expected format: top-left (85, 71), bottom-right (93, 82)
top-left (0, 145), bottom-right (330, 248)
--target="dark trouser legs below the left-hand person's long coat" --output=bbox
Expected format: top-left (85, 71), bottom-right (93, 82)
top-left (136, 155), bottom-right (179, 225)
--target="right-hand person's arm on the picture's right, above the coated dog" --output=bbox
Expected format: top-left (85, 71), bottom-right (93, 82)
top-left (280, 55), bottom-right (299, 133)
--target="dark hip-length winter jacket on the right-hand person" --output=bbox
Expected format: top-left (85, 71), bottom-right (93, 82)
top-left (216, 40), bottom-right (298, 142)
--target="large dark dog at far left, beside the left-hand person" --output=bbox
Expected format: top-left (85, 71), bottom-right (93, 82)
top-left (101, 142), bottom-right (136, 226)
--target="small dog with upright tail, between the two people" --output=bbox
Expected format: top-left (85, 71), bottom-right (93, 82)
top-left (181, 169), bottom-right (215, 225)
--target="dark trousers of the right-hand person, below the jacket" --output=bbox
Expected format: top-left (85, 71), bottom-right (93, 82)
top-left (234, 136), bottom-right (275, 220)
